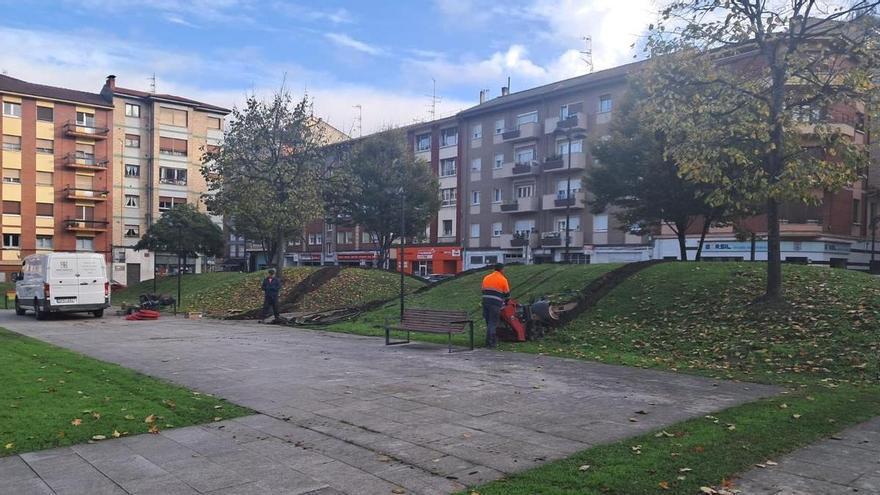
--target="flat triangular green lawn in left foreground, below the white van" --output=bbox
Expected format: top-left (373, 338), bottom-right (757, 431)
top-left (0, 328), bottom-right (251, 457)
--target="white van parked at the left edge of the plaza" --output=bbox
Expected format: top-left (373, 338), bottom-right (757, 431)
top-left (15, 253), bottom-right (110, 320)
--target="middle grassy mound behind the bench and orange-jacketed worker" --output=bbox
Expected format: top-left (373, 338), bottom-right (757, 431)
top-left (322, 264), bottom-right (619, 345)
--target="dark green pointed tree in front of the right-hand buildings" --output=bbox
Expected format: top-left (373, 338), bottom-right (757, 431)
top-left (587, 83), bottom-right (734, 261)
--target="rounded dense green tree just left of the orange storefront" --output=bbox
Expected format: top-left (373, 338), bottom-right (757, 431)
top-left (328, 130), bottom-right (440, 269)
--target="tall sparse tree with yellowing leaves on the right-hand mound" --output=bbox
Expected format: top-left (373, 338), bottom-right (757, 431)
top-left (646, 0), bottom-right (880, 301)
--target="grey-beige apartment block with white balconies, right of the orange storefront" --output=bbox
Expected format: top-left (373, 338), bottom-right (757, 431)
top-left (457, 64), bottom-right (651, 269)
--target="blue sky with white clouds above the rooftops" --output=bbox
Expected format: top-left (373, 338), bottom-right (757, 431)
top-left (0, 0), bottom-right (657, 135)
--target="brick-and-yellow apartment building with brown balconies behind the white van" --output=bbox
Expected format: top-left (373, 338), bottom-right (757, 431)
top-left (0, 75), bottom-right (114, 280)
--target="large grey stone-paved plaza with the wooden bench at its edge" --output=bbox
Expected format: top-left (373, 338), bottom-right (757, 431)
top-left (0, 312), bottom-right (777, 495)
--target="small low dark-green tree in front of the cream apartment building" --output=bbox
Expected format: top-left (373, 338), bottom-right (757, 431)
top-left (134, 204), bottom-right (224, 266)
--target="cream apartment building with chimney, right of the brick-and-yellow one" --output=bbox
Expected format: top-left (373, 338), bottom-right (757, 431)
top-left (102, 76), bottom-right (229, 285)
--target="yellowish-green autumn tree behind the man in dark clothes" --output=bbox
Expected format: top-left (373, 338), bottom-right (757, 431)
top-left (202, 88), bottom-right (327, 274)
